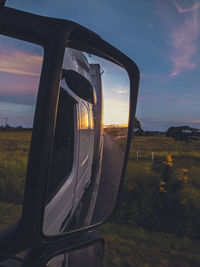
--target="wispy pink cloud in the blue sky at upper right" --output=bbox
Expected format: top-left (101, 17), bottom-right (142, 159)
top-left (170, 2), bottom-right (200, 77)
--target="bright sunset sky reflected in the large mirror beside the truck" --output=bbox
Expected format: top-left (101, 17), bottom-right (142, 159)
top-left (85, 53), bottom-right (129, 126)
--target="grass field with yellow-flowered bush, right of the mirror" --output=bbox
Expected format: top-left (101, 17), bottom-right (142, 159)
top-left (98, 136), bottom-right (200, 267)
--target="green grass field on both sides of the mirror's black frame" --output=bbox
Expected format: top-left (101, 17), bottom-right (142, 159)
top-left (0, 132), bottom-right (200, 267)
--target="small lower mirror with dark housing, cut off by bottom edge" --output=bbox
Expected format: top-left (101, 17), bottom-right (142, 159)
top-left (0, 241), bottom-right (104, 267)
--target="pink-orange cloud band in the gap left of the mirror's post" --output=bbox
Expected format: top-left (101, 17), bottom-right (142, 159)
top-left (0, 49), bottom-right (42, 77)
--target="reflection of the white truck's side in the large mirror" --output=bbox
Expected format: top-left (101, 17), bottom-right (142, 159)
top-left (43, 48), bottom-right (102, 235)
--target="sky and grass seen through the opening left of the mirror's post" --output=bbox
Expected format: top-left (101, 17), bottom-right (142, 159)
top-left (0, 36), bottom-right (43, 230)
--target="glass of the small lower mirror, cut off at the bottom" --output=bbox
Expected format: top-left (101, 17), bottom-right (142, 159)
top-left (46, 242), bottom-right (103, 267)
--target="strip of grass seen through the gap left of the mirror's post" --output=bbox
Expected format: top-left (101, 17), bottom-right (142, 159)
top-left (0, 132), bottom-right (31, 230)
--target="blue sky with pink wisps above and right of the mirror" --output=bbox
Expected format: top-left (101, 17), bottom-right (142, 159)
top-left (0, 0), bottom-right (200, 131)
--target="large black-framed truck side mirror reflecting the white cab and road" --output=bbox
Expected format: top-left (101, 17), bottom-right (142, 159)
top-left (0, 8), bottom-right (139, 254)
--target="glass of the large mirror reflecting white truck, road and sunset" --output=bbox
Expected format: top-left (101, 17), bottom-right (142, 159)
top-left (43, 48), bottom-right (129, 235)
